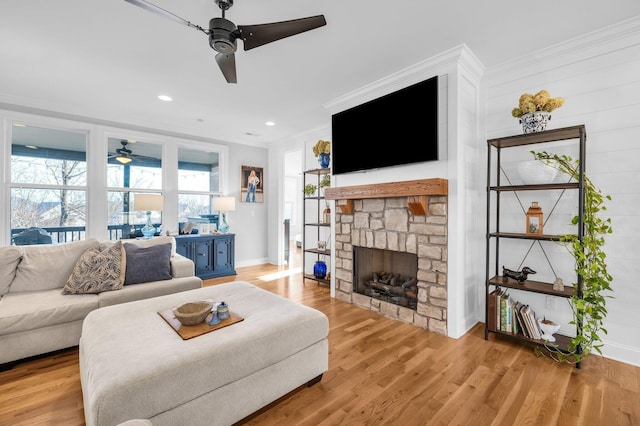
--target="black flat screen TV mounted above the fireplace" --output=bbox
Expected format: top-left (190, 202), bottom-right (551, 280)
top-left (331, 76), bottom-right (438, 174)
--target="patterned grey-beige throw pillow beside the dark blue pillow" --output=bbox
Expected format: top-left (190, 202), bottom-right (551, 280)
top-left (62, 241), bottom-right (126, 294)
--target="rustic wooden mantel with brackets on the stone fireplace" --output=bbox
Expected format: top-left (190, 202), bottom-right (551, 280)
top-left (324, 178), bottom-right (448, 215)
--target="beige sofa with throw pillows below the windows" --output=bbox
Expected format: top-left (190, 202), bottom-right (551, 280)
top-left (0, 237), bottom-right (202, 366)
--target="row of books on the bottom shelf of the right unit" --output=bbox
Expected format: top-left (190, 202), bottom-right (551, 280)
top-left (487, 287), bottom-right (542, 339)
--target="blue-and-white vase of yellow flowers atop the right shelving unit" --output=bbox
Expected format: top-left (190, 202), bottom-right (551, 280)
top-left (511, 90), bottom-right (564, 133)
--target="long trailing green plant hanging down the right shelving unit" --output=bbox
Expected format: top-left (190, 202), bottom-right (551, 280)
top-left (531, 151), bottom-right (613, 363)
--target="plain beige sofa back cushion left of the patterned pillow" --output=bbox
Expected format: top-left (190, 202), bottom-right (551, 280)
top-left (9, 238), bottom-right (100, 293)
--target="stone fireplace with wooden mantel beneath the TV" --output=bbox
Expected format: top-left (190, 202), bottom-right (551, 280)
top-left (325, 179), bottom-right (448, 335)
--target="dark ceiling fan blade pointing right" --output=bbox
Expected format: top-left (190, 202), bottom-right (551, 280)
top-left (241, 14), bottom-right (327, 50)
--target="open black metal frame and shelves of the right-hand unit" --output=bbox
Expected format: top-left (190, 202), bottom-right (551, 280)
top-left (485, 125), bottom-right (587, 368)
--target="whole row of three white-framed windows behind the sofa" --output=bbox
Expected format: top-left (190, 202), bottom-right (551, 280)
top-left (0, 114), bottom-right (228, 245)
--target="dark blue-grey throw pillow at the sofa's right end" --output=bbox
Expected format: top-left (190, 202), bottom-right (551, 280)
top-left (124, 243), bottom-right (172, 285)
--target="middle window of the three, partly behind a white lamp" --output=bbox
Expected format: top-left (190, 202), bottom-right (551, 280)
top-left (107, 138), bottom-right (162, 240)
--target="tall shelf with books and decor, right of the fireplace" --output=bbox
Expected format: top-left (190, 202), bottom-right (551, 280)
top-left (485, 125), bottom-right (586, 368)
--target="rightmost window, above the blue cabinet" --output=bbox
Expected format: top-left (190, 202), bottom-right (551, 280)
top-left (178, 148), bottom-right (220, 231)
